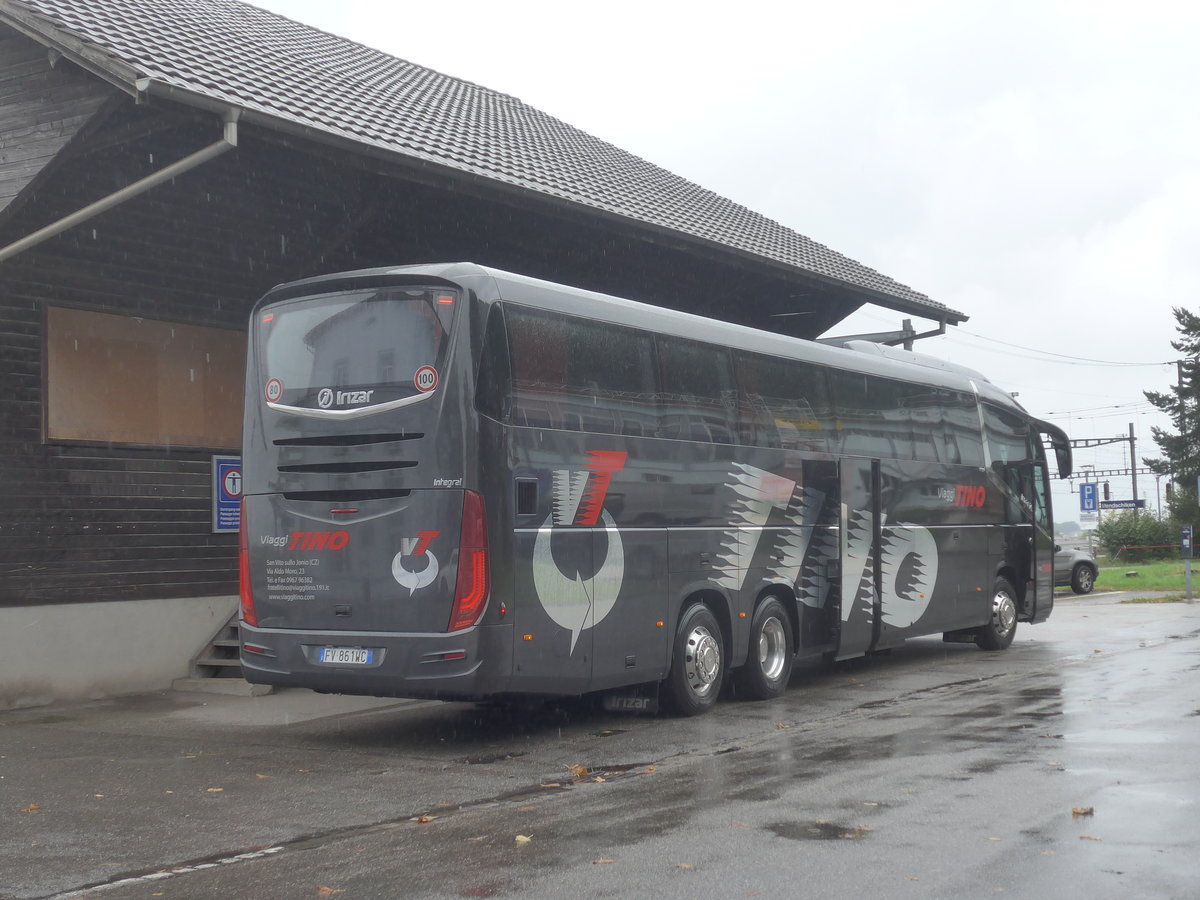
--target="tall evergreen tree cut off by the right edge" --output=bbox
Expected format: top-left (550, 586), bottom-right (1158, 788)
top-left (1142, 307), bottom-right (1200, 522)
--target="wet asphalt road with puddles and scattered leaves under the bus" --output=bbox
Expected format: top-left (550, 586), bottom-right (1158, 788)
top-left (0, 595), bottom-right (1200, 900)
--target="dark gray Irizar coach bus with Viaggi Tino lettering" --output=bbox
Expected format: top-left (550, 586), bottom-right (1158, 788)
top-left (241, 263), bottom-right (1070, 715)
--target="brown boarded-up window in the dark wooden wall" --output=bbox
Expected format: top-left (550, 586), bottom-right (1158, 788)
top-left (46, 306), bottom-right (246, 448)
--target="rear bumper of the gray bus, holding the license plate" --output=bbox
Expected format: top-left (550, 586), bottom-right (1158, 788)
top-left (240, 623), bottom-right (512, 700)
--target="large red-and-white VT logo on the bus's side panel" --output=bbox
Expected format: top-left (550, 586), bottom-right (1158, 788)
top-left (533, 450), bottom-right (628, 653)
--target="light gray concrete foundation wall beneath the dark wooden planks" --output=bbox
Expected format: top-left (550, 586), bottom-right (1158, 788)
top-left (0, 596), bottom-right (238, 709)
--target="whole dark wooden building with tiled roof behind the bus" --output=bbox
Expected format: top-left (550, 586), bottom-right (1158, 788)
top-left (0, 0), bottom-right (965, 708)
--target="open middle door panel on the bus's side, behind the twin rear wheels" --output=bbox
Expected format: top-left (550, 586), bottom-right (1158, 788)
top-left (836, 457), bottom-right (883, 659)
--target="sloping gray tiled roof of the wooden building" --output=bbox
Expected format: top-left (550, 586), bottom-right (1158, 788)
top-left (0, 0), bottom-right (962, 320)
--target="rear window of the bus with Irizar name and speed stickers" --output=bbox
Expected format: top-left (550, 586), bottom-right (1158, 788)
top-left (256, 287), bottom-right (458, 409)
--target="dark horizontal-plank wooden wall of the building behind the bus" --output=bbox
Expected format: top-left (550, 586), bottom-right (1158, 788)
top-left (0, 31), bottom-right (864, 605)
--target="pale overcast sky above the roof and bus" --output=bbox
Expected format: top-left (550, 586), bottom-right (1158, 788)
top-left (250, 0), bottom-right (1200, 521)
